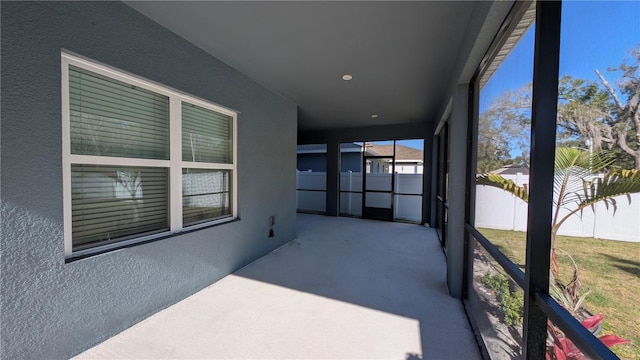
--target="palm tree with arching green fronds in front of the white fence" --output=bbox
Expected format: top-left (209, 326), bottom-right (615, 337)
top-left (477, 147), bottom-right (640, 278)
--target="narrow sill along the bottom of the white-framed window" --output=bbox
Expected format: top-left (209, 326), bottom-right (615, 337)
top-left (64, 217), bottom-right (240, 264)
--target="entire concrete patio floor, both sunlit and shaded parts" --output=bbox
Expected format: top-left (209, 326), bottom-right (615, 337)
top-left (76, 215), bottom-right (481, 360)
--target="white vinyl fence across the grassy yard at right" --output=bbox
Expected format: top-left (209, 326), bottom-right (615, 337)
top-left (475, 174), bottom-right (640, 242)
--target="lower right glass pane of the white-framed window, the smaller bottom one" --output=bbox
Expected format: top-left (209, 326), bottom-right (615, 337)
top-left (182, 169), bottom-right (231, 226)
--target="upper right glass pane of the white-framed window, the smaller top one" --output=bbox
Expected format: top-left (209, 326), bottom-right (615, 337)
top-left (182, 102), bottom-right (233, 164)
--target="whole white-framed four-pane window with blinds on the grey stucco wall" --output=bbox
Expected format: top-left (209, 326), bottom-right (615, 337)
top-left (62, 53), bottom-right (237, 256)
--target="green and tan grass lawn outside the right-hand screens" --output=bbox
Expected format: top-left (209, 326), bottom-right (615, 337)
top-left (479, 229), bottom-right (640, 360)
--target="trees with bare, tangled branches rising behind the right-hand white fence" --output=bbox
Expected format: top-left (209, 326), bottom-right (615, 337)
top-left (478, 46), bottom-right (640, 173)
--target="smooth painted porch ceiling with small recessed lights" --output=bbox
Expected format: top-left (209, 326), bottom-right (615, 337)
top-left (127, 1), bottom-right (504, 130)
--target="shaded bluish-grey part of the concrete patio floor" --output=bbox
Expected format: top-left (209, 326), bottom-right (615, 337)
top-left (235, 214), bottom-right (480, 359)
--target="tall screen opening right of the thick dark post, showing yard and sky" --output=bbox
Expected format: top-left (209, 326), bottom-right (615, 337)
top-left (551, 1), bottom-right (640, 359)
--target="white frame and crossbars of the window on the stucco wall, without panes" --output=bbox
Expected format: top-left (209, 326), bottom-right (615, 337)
top-left (61, 52), bottom-right (238, 258)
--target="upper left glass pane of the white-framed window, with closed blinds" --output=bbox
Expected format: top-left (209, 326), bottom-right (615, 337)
top-left (69, 66), bottom-right (169, 159)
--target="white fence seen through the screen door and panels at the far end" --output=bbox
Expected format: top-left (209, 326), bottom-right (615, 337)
top-left (296, 171), bottom-right (422, 222)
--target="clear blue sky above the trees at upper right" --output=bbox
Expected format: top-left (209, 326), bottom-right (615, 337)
top-left (480, 0), bottom-right (640, 112)
